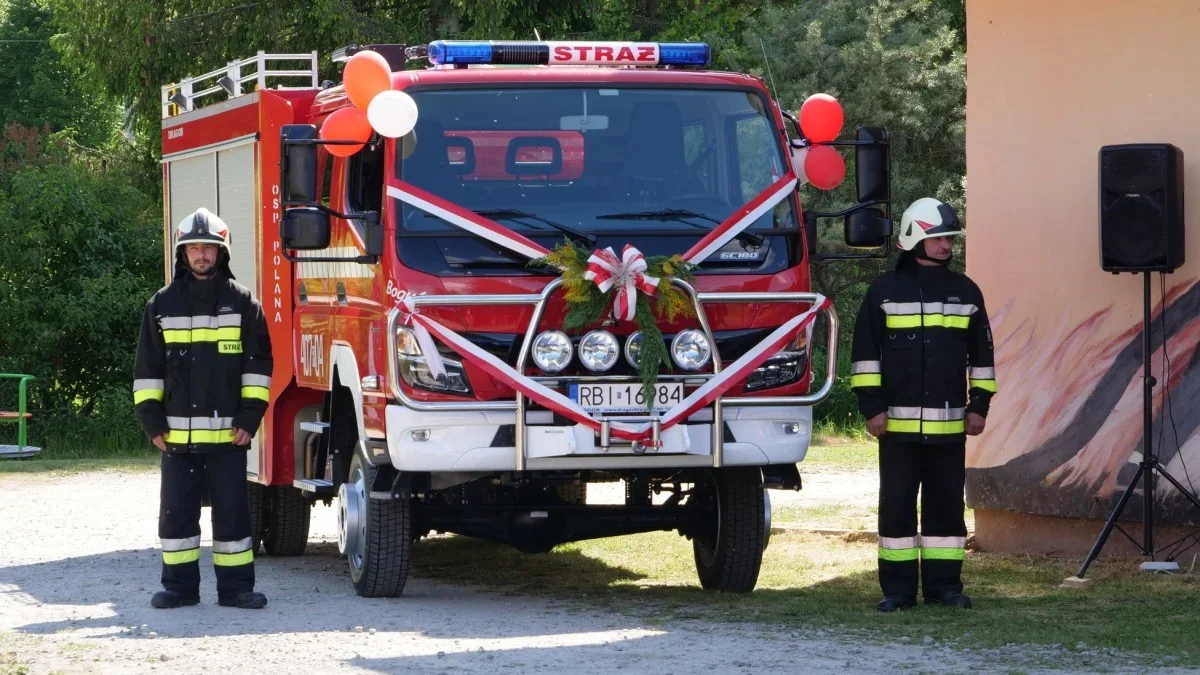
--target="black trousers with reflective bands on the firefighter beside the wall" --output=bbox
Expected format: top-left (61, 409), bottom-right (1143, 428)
top-left (880, 435), bottom-right (967, 598)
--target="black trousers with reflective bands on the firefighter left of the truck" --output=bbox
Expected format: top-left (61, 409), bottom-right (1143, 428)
top-left (158, 449), bottom-right (254, 597)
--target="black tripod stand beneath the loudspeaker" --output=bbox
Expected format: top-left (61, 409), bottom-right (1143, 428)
top-left (1075, 271), bottom-right (1200, 579)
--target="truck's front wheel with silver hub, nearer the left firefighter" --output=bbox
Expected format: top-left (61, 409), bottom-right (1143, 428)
top-left (337, 454), bottom-right (413, 598)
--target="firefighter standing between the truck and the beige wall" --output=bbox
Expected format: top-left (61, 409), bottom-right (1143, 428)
top-left (851, 197), bottom-right (996, 611)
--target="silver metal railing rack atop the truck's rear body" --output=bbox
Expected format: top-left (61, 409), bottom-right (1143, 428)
top-left (162, 52), bottom-right (319, 119)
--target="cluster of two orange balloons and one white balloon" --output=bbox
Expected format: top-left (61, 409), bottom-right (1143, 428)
top-left (320, 52), bottom-right (416, 157)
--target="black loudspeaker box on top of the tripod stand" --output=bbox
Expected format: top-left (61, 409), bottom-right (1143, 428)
top-left (1100, 143), bottom-right (1183, 273)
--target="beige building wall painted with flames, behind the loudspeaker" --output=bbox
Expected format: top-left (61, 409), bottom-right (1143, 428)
top-left (966, 0), bottom-right (1200, 550)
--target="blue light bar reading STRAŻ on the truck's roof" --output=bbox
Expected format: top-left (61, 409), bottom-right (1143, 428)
top-left (428, 40), bottom-right (712, 66)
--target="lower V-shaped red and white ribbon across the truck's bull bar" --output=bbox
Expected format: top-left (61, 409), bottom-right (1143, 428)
top-left (412, 295), bottom-right (830, 441)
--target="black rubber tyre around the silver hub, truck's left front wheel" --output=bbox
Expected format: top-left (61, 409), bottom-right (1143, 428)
top-left (346, 454), bottom-right (413, 598)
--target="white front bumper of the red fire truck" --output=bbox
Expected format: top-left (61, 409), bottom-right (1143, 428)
top-left (388, 405), bottom-right (812, 472)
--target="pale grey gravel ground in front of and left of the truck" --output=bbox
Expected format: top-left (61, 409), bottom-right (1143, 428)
top-left (0, 466), bottom-right (1185, 674)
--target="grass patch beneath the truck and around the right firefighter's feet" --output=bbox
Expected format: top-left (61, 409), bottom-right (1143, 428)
top-left (413, 532), bottom-right (1200, 668)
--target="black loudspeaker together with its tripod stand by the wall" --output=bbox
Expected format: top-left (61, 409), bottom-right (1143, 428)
top-left (1068, 143), bottom-right (1200, 581)
